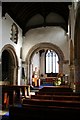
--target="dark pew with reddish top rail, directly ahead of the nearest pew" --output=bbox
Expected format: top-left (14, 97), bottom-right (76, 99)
top-left (22, 99), bottom-right (80, 108)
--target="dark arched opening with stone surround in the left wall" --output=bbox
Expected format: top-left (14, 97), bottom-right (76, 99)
top-left (1, 44), bottom-right (18, 85)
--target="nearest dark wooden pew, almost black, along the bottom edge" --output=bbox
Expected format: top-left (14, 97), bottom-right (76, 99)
top-left (9, 104), bottom-right (80, 120)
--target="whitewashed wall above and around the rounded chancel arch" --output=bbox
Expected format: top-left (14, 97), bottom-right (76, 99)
top-left (23, 27), bottom-right (69, 74)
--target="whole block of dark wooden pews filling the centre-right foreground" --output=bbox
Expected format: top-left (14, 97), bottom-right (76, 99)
top-left (9, 86), bottom-right (80, 120)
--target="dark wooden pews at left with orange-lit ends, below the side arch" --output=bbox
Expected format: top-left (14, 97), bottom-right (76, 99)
top-left (0, 85), bottom-right (28, 109)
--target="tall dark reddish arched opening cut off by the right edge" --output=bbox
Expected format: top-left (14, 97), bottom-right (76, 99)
top-left (73, 2), bottom-right (80, 92)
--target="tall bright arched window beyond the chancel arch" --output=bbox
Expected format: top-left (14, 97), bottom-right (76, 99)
top-left (45, 50), bottom-right (59, 73)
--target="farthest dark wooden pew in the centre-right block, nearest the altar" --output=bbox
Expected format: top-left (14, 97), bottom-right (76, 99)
top-left (35, 86), bottom-right (80, 96)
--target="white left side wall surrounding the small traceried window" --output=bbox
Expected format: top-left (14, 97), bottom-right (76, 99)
top-left (2, 13), bottom-right (22, 84)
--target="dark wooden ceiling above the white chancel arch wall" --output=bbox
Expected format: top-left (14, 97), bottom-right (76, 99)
top-left (2, 2), bottom-right (72, 34)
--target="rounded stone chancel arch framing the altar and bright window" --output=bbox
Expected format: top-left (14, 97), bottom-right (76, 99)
top-left (25, 43), bottom-right (65, 83)
